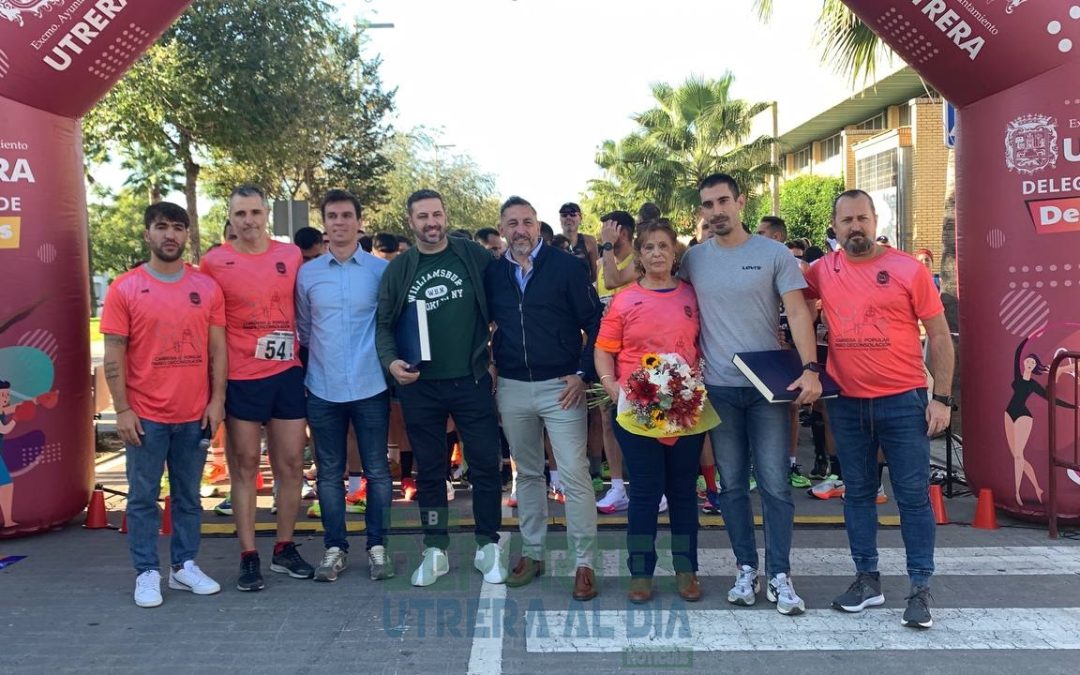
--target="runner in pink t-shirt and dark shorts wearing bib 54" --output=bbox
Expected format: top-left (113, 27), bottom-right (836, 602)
top-left (202, 186), bottom-right (315, 591)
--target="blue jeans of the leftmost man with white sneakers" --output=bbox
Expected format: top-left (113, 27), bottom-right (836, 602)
top-left (125, 419), bottom-right (206, 573)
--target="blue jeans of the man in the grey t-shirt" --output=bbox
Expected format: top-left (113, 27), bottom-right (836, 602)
top-left (706, 386), bottom-right (795, 577)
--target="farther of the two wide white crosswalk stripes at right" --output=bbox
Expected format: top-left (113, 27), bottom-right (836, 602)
top-left (548, 541), bottom-right (1080, 577)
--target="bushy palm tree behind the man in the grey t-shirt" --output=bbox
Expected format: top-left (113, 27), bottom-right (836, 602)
top-left (584, 72), bottom-right (779, 232)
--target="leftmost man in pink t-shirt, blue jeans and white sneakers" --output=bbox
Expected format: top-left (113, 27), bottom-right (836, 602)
top-left (102, 202), bottom-right (228, 607)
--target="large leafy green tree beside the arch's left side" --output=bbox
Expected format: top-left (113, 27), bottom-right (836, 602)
top-left (84, 0), bottom-right (392, 258)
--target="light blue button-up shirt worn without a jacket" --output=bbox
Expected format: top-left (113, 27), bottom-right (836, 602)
top-left (296, 247), bottom-right (389, 403)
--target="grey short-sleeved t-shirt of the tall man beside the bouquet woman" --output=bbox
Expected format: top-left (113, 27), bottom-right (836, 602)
top-left (679, 234), bottom-right (807, 387)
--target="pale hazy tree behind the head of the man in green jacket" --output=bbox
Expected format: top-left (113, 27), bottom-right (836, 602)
top-left (364, 127), bottom-right (499, 235)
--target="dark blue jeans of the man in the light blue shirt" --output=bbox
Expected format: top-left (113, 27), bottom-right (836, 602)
top-left (308, 391), bottom-right (393, 551)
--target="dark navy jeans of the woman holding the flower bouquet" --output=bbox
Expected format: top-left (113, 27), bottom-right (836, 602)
top-left (611, 420), bottom-right (705, 577)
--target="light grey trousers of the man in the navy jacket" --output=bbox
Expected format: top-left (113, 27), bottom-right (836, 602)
top-left (495, 377), bottom-right (596, 568)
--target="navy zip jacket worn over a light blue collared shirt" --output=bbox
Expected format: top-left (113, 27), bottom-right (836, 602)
top-left (484, 244), bottom-right (603, 382)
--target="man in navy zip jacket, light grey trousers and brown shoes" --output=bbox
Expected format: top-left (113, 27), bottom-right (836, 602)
top-left (484, 197), bottom-right (602, 600)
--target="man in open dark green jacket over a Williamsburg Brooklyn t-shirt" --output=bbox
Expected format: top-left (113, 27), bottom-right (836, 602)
top-left (376, 190), bottom-right (508, 586)
